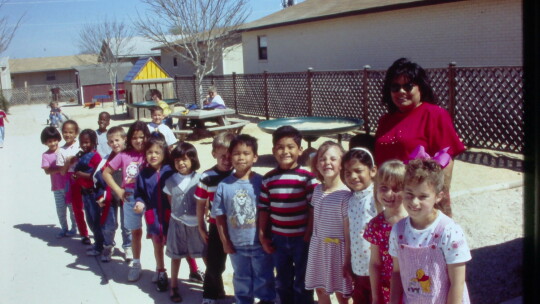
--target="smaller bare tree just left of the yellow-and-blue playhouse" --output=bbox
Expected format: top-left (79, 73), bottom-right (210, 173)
top-left (77, 19), bottom-right (134, 114)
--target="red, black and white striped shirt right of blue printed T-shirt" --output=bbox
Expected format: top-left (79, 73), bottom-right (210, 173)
top-left (258, 166), bottom-right (318, 237)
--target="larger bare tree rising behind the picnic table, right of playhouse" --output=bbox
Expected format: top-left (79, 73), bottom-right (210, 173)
top-left (136, 0), bottom-right (249, 106)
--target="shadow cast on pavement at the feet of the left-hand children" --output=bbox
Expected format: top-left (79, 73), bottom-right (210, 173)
top-left (14, 224), bottom-right (215, 303)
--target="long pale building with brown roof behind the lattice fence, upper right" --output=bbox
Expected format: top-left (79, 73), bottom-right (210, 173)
top-left (241, 0), bottom-right (523, 73)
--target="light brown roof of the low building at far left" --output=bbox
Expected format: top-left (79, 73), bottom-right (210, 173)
top-left (9, 54), bottom-right (98, 74)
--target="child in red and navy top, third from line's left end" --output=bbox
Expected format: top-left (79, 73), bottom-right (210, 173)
top-left (72, 129), bottom-right (103, 256)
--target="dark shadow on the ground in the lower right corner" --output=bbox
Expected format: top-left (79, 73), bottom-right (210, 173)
top-left (467, 238), bottom-right (523, 304)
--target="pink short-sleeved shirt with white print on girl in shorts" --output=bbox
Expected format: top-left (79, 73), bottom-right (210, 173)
top-left (109, 151), bottom-right (144, 189)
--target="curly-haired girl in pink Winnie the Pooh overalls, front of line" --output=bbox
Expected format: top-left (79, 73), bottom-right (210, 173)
top-left (389, 159), bottom-right (471, 304)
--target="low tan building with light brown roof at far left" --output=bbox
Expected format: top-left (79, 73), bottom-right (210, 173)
top-left (9, 54), bottom-right (98, 88)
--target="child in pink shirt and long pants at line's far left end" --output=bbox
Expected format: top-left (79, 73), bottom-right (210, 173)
top-left (41, 127), bottom-right (77, 238)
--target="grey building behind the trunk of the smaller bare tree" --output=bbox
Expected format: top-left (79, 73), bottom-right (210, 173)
top-left (74, 62), bottom-right (133, 104)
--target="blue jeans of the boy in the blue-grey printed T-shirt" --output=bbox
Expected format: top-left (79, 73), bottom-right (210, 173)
top-left (229, 245), bottom-right (276, 304)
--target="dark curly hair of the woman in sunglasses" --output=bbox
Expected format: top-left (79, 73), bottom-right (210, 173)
top-left (382, 58), bottom-right (437, 113)
